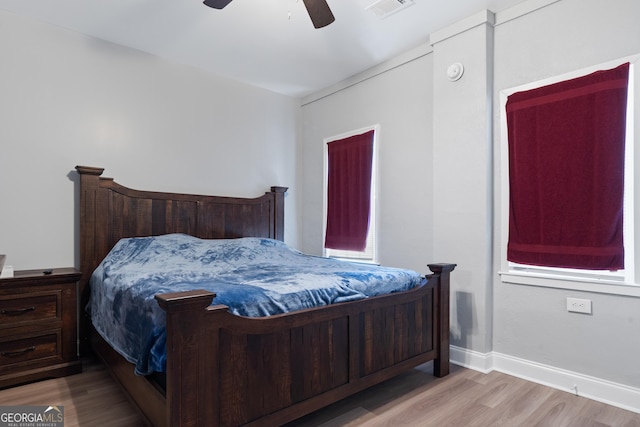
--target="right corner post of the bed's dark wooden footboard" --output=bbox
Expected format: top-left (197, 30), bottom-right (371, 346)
top-left (429, 264), bottom-right (456, 378)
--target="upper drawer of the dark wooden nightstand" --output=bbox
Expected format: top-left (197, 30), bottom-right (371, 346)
top-left (0, 291), bottom-right (60, 328)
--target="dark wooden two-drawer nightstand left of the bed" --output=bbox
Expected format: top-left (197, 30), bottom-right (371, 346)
top-left (0, 268), bottom-right (82, 388)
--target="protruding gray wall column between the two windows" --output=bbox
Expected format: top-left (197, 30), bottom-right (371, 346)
top-left (431, 12), bottom-right (493, 353)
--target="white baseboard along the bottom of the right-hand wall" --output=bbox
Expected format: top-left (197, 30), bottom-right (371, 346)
top-left (450, 346), bottom-right (640, 413)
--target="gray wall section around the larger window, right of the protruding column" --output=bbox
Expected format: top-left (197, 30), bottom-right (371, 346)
top-left (493, 0), bottom-right (640, 388)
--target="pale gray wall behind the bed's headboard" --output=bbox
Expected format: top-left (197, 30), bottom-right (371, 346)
top-left (0, 12), bottom-right (300, 269)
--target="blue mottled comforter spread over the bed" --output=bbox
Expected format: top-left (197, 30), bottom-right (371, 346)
top-left (87, 234), bottom-right (425, 375)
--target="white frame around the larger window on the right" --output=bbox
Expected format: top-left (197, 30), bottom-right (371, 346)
top-left (499, 54), bottom-right (640, 297)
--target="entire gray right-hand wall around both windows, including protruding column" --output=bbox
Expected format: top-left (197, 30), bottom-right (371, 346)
top-left (300, 0), bottom-right (640, 411)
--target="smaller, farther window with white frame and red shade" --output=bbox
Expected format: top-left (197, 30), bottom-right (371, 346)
top-left (324, 126), bottom-right (378, 262)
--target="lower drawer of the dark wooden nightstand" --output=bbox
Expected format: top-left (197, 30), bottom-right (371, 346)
top-left (0, 331), bottom-right (61, 370)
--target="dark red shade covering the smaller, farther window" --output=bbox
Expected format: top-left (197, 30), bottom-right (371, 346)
top-left (324, 130), bottom-right (374, 251)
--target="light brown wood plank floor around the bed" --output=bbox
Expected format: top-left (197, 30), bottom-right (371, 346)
top-left (0, 360), bottom-right (640, 427)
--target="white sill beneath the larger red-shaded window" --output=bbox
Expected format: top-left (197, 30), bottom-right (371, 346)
top-left (499, 271), bottom-right (640, 298)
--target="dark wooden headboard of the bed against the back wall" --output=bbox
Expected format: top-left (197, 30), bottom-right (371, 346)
top-left (76, 166), bottom-right (287, 352)
